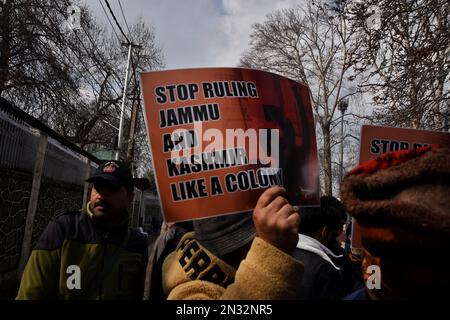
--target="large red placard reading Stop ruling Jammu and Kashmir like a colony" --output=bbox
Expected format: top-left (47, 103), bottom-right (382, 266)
top-left (141, 68), bottom-right (319, 222)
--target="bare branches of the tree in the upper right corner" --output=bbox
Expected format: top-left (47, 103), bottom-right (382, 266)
top-left (348, 0), bottom-right (450, 130)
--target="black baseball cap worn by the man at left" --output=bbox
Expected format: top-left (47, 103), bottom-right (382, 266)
top-left (86, 160), bottom-right (134, 191)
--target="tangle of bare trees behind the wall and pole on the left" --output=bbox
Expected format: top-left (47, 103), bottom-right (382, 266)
top-left (0, 0), bottom-right (163, 156)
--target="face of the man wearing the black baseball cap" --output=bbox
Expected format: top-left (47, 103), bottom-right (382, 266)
top-left (90, 180), bottom-right (134, 222)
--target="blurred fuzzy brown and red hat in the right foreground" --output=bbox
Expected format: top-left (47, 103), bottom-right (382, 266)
top-left (341, 146), bottom-right (450, 258)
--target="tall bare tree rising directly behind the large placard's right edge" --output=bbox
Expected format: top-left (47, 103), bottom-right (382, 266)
top-left (241, 1), bottom-right (353, 195)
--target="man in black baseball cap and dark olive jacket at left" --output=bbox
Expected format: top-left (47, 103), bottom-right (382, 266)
top-left (16, 161), bottom-right (148, 300)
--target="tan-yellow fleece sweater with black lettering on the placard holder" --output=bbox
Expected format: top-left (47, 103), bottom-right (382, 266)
top-left (162, 232), bottom-right (303, 300)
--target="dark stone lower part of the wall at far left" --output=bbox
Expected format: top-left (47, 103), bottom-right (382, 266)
top-left (0, 168), bottom-right (83, 299)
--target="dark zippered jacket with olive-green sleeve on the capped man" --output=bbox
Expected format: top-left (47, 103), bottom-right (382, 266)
top-left (16, 204), bottom-right (148, 300)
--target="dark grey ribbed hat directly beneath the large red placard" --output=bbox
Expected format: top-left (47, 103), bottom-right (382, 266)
top-left (194, 212), bottom-right (256, 257)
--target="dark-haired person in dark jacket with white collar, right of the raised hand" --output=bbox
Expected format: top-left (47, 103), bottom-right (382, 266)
top-left (293, 196), bottom-right (346, 300)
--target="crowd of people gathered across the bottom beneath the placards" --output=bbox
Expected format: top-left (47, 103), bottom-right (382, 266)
top-left (17, 146), bottom-right (450, 300)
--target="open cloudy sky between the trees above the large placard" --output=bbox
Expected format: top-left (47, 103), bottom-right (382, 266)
top-left (86, 0), bottom-right (302, 69)
